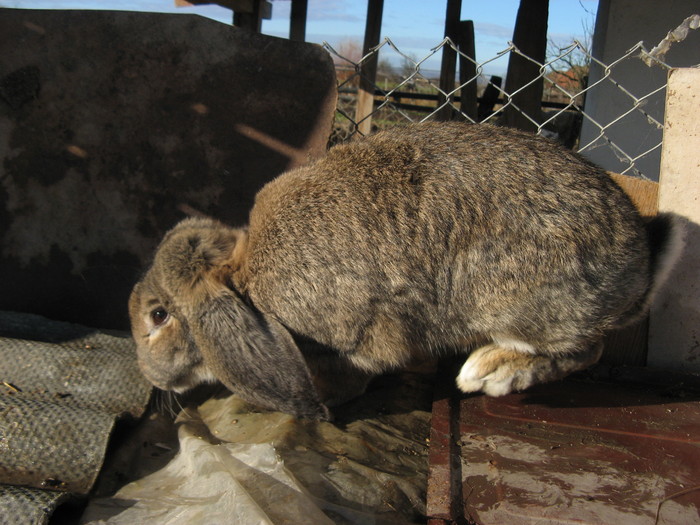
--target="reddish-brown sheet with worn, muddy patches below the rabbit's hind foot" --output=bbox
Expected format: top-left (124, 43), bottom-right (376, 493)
top-left (428, 364), bottom-right (700, 525)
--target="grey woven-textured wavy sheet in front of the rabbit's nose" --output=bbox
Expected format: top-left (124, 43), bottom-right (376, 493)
top-left (0, 312), bottom-right (151, 524)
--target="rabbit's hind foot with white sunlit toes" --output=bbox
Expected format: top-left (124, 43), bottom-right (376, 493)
top-left (457, 342), bottom-right (603, 396)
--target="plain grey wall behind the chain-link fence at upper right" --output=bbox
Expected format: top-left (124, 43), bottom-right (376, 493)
top-left (581, 0), bottom-right (700, 180)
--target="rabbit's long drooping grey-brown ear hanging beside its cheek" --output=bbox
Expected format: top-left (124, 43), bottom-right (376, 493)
top-left (191, 288), bottom-right (329, 419)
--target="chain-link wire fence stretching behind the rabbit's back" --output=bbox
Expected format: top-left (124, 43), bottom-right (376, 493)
top-left (323, 15), bottom-right (700, 179)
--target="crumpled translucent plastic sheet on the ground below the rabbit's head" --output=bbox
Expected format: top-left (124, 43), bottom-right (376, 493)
top-left (82, 373), bottom-right (432, 525)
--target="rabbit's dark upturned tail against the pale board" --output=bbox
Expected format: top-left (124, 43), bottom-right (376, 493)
top-left (618, 213), bottom-right (685, 326)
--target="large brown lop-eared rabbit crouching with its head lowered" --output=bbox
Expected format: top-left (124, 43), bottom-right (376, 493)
top-left (129, 123), bottom-right (682, 419)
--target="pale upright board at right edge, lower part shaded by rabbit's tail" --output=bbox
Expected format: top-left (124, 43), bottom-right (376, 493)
top-left (647, 68), bottom-right (700, 373)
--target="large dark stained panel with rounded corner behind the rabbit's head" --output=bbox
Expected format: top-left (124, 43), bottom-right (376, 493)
top-left (0, 9), bottom-right (336, 328)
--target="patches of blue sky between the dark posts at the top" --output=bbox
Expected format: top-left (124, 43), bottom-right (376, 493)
top-left (0, 0), bottom-right (598, 74)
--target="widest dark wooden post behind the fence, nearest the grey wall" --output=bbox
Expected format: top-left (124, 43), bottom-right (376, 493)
top-left (504, 0), bottom-right (549, 131)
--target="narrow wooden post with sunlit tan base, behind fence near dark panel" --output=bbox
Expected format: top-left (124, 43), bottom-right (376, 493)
top-left (355, 0), bottom-right (384, 135)
